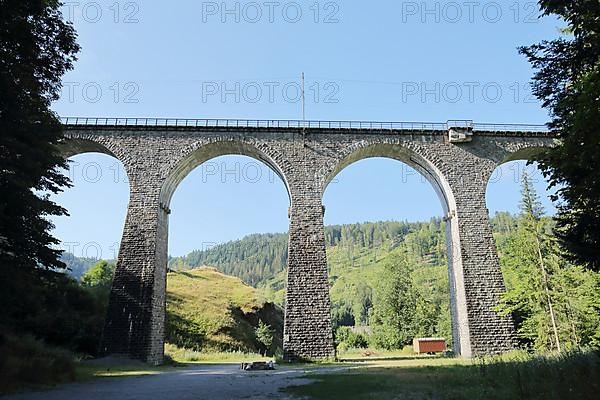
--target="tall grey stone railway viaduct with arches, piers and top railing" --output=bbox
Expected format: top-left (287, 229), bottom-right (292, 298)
top-left (62, 118), bottom-right (554, 364)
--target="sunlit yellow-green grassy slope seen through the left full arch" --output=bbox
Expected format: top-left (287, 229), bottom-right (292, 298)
top-left (167, 268), bottom-right (283, 351)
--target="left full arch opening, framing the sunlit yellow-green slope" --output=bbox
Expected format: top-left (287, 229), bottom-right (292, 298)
top-left (159, 142), bottom-right (290, 356)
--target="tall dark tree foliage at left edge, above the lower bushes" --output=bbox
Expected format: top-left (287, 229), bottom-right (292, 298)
top-left (0, 0), bottom-right (79, 269)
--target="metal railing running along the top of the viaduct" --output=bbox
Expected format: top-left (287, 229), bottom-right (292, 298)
top-left (61, 117), bottom-right (547, 132)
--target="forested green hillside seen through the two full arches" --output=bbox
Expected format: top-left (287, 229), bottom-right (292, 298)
top-left (170, 218), bottom-right (451, 348)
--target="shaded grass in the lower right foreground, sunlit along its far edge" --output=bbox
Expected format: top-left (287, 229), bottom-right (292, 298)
top-left (284, 351), bottom-right (600, 400)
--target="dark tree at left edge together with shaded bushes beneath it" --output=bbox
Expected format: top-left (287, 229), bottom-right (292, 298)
top-left (0, 0), bottom-right (97, 353)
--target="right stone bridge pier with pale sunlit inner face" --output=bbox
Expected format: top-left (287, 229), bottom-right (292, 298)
top-left (447, 170), bottom-right (516, 357)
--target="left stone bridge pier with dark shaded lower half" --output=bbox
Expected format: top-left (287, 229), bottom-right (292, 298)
top-left (100, 185), bottom-right (168, 365)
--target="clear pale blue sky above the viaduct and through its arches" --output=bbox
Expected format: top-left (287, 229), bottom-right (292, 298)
top-left (54, 0), bottom-right (560, 258)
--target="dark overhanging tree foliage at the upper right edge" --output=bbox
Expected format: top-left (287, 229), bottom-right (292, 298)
top-left (520, 0), bottom-right (600, 270)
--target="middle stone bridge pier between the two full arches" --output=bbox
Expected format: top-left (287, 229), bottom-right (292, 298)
top-left (283, 194), bottom-right (335, 361)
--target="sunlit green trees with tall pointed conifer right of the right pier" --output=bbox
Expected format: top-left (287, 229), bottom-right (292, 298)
top-left (498, 175), bottom-right (600, 351)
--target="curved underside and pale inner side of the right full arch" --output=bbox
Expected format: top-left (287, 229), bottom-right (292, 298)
top-left (322, 141), bottom-right (472, 357)
